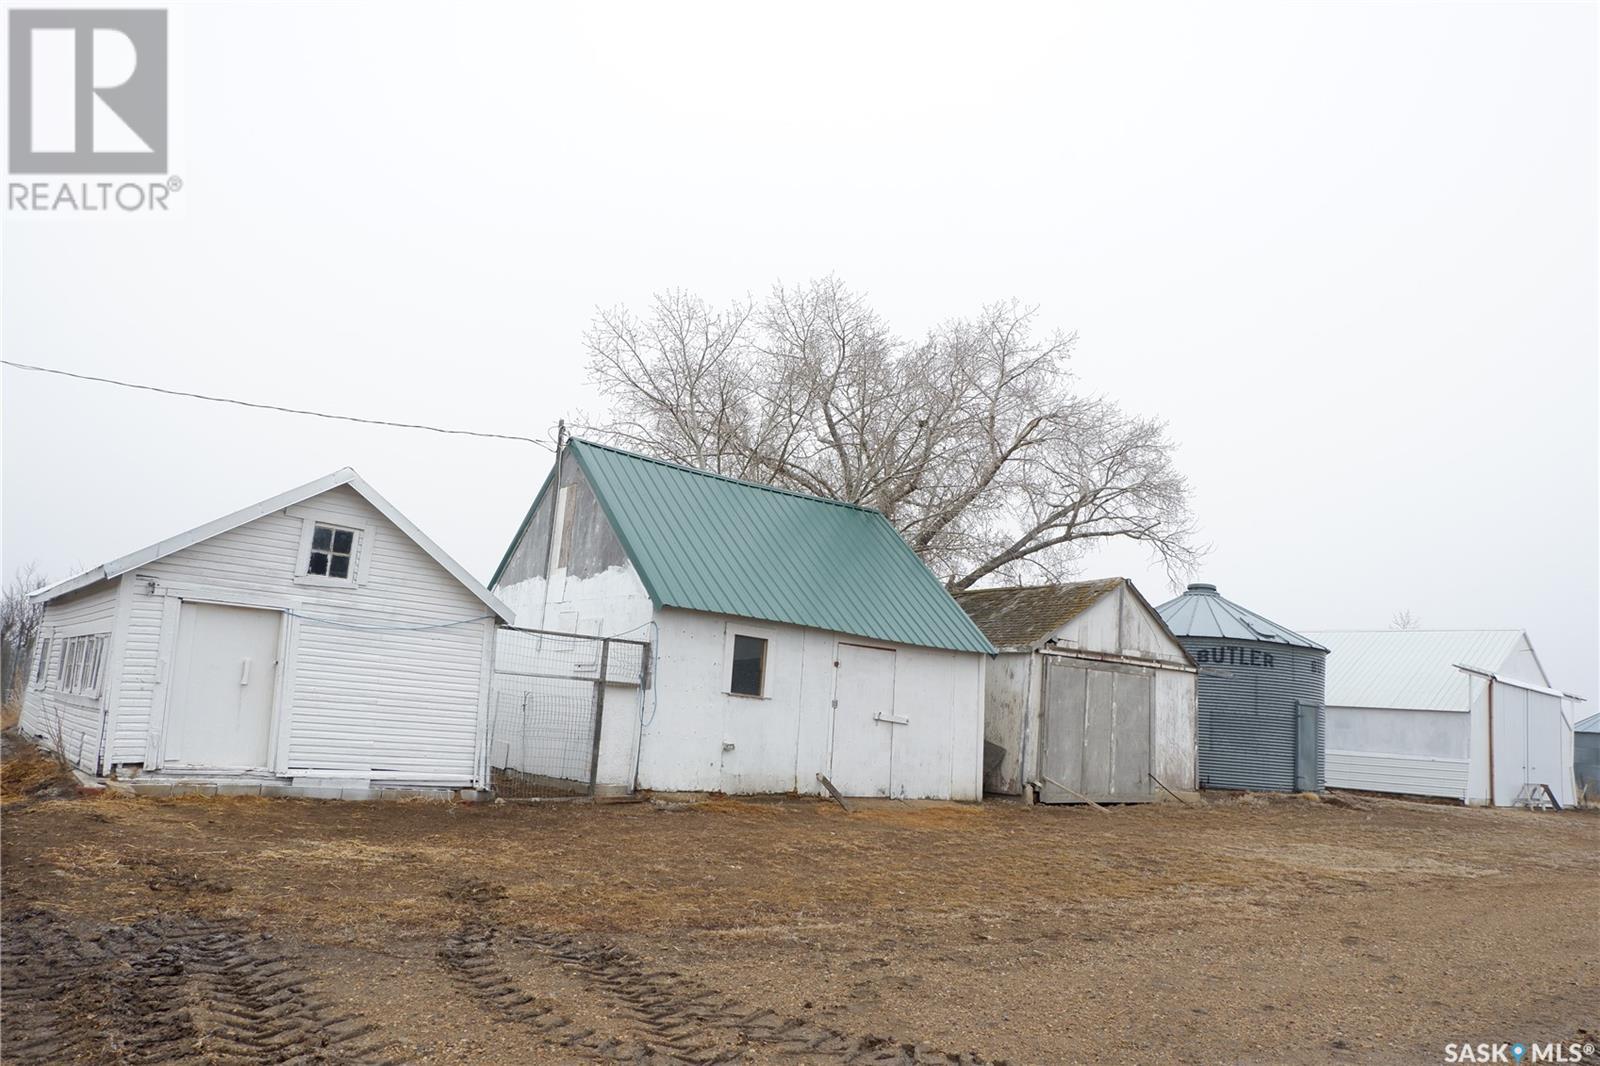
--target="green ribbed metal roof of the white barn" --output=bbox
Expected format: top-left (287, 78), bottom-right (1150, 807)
top-left (570, 439), bottom-right (994, 653)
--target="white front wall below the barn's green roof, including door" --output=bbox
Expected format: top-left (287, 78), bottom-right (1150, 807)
top-left (656, 608), bottom-right (982, 799)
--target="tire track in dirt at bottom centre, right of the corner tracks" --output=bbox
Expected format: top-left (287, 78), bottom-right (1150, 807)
top-left (440, 892), bottom-right (1005, 1066)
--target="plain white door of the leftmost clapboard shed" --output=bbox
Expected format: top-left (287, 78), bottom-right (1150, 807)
top-left (166, 603), bottom-right (283, 770)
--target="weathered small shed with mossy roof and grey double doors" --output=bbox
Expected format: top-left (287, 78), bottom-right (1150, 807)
top-left (955, 578), bottom-right (1197, 804)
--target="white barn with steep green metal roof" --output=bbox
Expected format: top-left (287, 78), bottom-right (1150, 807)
top-left (490, 439), bottom-right (994, 799)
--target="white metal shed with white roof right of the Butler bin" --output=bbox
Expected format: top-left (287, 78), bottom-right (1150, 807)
top-left (1306, 629), bottom-right (1576, 807)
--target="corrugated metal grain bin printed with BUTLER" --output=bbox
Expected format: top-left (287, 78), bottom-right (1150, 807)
top-left (1157, 584), bottom-right (1328, 792)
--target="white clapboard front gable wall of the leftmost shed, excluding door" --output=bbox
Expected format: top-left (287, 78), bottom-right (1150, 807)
top-left (112, 487), bottom-right (494, 781)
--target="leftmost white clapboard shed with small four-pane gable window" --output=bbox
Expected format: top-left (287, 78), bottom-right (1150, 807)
top-left (21, 469), bottom-right (510, 794)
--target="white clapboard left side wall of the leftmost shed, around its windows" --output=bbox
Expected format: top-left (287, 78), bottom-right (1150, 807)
top-left (19, 581), bottom-right (117, 773)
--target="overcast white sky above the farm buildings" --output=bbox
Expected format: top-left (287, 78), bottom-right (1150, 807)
top-left (0, 3), bottom-right (1600, 697)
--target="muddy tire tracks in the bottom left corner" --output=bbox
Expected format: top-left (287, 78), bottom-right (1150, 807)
top-left (0, 909), bottom-right (395, 1066)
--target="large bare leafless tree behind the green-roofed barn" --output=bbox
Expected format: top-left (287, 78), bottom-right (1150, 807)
top-left (584, 277), bottom-right (1200, 587)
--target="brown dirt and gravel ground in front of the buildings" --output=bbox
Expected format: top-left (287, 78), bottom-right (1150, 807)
top-left (0, 729), bottom-right (1600, 1063)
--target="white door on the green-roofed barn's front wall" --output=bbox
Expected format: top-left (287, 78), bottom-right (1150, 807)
top-left (827, 643), bottom-right (904, 795)
